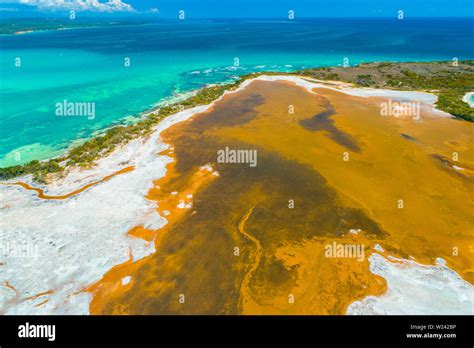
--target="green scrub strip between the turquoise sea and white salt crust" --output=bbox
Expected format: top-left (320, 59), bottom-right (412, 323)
top-left (0, 60), bottom-right (474, 182)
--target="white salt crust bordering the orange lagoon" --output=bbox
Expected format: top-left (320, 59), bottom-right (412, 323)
top-left (0, 76), bottom-right (473, 314)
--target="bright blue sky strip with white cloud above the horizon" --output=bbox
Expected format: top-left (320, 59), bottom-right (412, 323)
top-left (0, 0), bottom-right (474, 18)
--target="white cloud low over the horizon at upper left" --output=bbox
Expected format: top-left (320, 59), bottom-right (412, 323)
top-left (20, 0), bottom-right (135, 12)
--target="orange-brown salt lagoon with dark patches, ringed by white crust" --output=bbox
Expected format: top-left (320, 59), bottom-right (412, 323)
top-left (87, 81), bottom-right (474, 314)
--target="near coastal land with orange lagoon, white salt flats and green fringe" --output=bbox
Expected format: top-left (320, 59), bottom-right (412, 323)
top-left (0, 63), bottom-right (474, 314)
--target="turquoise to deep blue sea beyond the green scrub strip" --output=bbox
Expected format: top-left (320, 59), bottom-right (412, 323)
top-left (0, 19), bottom-right (474, 167)
